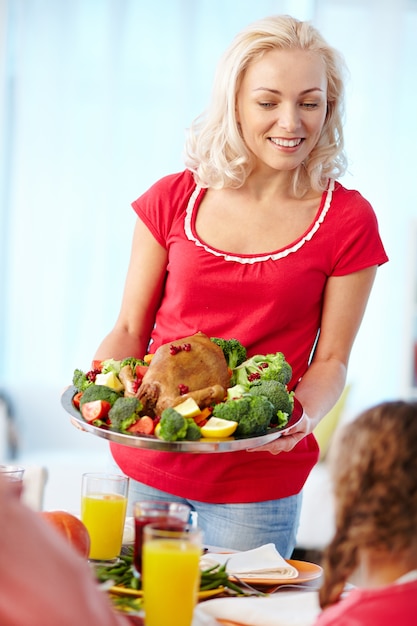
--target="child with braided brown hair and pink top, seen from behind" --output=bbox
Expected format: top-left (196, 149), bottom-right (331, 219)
top-left (316, 401), bottom-right (417, 626)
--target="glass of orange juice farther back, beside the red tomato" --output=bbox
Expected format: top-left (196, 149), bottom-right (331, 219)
top-left (81, 472), bottom-right (129, 561)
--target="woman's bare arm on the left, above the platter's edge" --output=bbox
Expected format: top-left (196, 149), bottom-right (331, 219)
top-left (94, 219), bottom-right (167, 360)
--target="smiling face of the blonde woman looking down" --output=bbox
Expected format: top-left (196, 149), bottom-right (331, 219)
top-left (236, 49), bottom-right (327, 171)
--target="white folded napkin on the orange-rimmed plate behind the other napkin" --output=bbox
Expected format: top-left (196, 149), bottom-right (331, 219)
top-left (201, 543), bottom-right (298, 580)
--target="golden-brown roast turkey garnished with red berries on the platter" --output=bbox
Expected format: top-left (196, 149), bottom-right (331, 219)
top-left (136, 332), bottom-right (231, 415)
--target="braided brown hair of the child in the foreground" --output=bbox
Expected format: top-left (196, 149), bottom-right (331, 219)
top-left (319, 401), bottom-right (417, 608)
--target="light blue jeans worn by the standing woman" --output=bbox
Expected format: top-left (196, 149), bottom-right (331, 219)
top-left (128, 479), bottom-right (302, 559)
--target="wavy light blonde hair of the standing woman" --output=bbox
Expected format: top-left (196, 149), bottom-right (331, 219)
top-left (185, 15), bottom-right (347, 196)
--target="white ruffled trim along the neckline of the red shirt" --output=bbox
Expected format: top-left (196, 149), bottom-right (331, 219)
top-left (184, 179), bottom-right (335, 264)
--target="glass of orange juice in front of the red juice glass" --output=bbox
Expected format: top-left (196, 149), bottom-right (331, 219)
top-left (142, 519), bottom-right (202, 626)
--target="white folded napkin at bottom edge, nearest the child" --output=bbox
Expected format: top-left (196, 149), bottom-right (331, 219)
top-left (193, 591), bottom-right (320, 626)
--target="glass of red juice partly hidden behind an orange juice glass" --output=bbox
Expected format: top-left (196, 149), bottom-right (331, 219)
top-left (133, 500), bottom-right (191, 578)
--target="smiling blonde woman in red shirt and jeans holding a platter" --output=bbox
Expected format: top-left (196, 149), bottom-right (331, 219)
top-left (94, 16), bottom-right (387, 557)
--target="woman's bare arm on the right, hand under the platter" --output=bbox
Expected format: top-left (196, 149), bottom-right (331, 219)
top-left (250, 266), bottom-right (377, 454)
